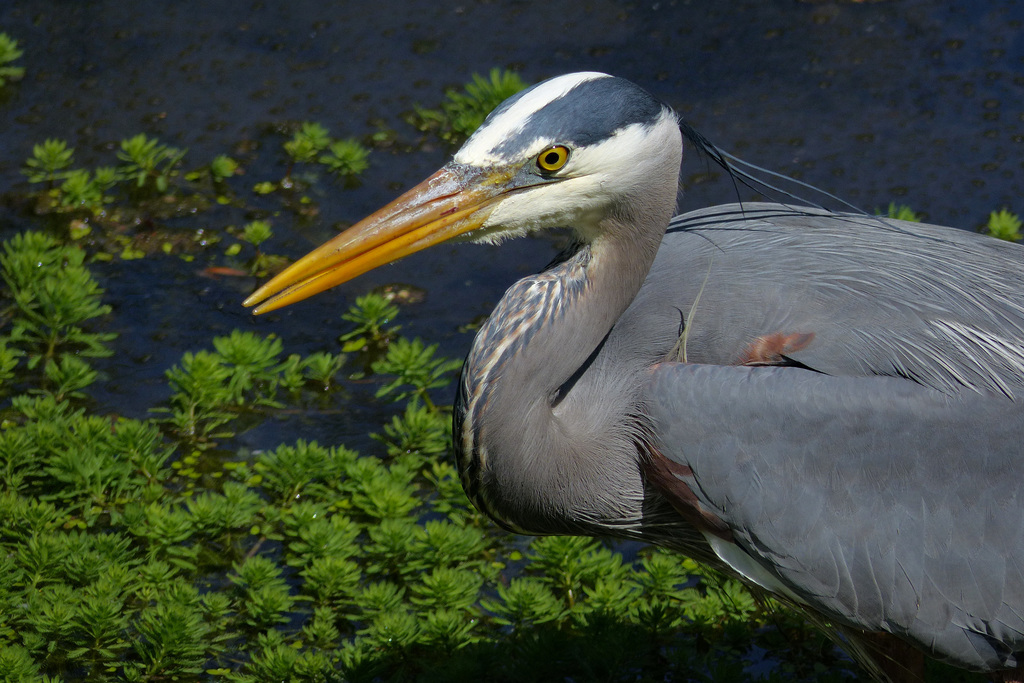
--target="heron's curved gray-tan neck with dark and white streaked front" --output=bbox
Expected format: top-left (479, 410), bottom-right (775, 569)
top-left (456, 208), bottom-right (669, 532)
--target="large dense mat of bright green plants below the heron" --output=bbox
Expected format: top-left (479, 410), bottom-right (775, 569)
top-left (0, 232), bottom-right (864, 682)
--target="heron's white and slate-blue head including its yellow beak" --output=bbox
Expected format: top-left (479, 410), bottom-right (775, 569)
top-left (245, 73), bottom-right (682, 313)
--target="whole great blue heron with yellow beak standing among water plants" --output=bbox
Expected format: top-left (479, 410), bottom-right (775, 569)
top-left (246, 73), bottom-right (1024, 676)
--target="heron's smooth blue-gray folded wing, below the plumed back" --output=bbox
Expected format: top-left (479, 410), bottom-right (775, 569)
top-left (645, 362), bottom-right (1024, 669)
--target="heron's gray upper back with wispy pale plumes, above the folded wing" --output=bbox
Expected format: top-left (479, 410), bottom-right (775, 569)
top-left (638, 204), bottom-right (1024, 397)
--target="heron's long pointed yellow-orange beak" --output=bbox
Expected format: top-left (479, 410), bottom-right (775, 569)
top-left (244, 164), bottom-right (509, 313)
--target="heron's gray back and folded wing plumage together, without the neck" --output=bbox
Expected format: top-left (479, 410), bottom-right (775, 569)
top-left (622, 204), bottom-right (1024, 669)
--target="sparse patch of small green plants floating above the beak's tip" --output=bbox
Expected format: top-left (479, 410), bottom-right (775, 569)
top-left (13, 123), bottom-right (370, 270)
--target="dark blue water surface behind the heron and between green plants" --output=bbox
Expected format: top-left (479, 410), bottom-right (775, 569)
top-left (0, 0), bottom-right (1024, 447)
